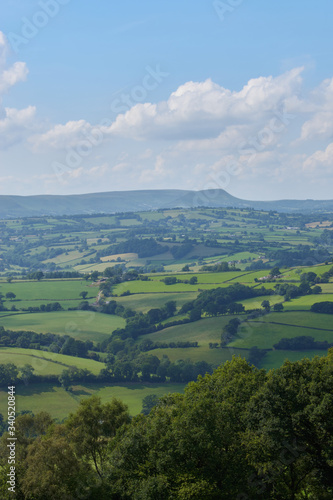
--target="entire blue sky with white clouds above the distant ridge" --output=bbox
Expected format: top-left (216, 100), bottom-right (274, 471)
top-left (0, 0), bottom-right (333, 199)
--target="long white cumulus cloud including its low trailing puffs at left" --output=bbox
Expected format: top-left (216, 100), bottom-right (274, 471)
top-left (27, 68), bottom-right (303, 151)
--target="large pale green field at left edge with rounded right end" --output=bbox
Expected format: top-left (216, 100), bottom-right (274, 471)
top-left (0, 311), bottom-right (125, 342)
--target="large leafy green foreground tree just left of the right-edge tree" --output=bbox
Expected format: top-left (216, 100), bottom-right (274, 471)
top-left (109, 358), bottom-right (266, 500)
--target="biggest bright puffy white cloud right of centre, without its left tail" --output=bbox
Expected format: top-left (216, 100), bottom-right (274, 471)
top-left (110, 68), bottom-right (303, 140)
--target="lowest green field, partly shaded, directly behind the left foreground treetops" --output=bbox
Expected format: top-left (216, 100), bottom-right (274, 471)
top-left (0, 383), bottom-right (185, 420)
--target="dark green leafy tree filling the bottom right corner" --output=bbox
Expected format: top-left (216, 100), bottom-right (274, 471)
top-left (244, 350), bottom-right (333, 500)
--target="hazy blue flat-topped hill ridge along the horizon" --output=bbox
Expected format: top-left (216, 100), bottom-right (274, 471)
top-left (0, 189), bottom-right (333, 219)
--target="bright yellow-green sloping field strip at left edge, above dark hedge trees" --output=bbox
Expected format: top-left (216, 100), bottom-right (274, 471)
top-left (0, 347), bottom-right (105, 375)
